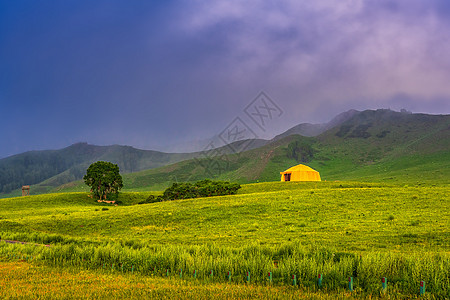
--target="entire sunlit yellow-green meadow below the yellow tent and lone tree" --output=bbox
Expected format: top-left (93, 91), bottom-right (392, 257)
top-left (0, 182), bottom-right (450, 299)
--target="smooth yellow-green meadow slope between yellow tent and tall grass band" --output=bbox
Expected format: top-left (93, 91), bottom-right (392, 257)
top-left (0, 182), bottom-right (450, 251)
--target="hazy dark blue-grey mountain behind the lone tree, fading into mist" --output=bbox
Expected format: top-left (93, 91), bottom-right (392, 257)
top-left (0, 143), bottom-right (195, 193)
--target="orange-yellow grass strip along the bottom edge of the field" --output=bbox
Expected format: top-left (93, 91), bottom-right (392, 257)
top-left (0, 262), bottom-right (435, 299)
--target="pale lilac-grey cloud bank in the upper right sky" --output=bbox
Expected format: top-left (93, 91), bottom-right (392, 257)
top-left (175, 1), bottom-right (449, 118)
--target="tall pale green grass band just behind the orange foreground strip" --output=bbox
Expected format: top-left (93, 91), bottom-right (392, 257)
top-left (0, 242), bottom-right (450, 298)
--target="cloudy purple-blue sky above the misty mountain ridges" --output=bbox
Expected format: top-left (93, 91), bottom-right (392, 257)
top-left (0, 0), bottom-right (450, 158)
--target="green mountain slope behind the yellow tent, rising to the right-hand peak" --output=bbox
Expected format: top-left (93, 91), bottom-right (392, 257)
top-left (74, 110), bottom-right (450, 190)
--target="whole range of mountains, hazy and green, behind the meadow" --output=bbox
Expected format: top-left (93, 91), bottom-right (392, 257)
top-left (0, 110), bottom-right (450, 197)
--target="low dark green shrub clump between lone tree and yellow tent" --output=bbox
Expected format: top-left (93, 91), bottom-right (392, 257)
top-left (139, 179), bottom-right (241, 204)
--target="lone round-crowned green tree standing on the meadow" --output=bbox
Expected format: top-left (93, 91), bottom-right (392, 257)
top-left (83, 161), bottom-right (123, 200)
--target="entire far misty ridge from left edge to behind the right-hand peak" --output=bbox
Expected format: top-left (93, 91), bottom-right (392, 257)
top-left (0, 110), bottom-right (356, 196)
